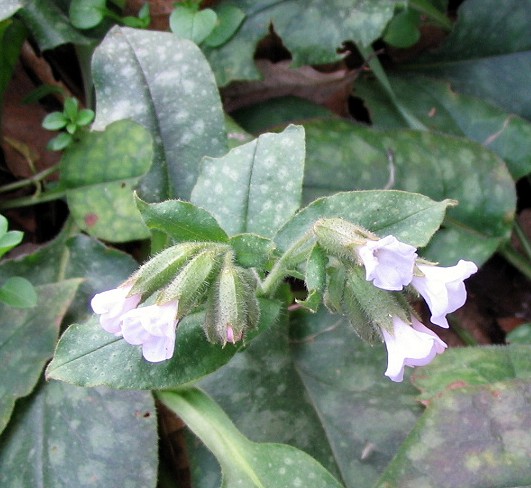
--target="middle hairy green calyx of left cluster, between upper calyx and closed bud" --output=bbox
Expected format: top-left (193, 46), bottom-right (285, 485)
top-left (157, 245), bottom-right (227, 318)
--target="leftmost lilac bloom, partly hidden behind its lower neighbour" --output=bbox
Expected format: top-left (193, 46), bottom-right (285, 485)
top-left (90, 285), bottom-right (141, 336)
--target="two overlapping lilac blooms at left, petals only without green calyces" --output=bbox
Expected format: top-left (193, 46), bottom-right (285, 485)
top-left (91, 285), bottom-right (178, 363)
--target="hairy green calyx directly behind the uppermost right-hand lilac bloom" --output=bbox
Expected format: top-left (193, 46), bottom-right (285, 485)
top-left (313, 218), bottom-right (374, 261)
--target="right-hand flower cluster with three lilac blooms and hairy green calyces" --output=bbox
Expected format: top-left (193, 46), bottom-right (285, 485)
top-left (314, 218), bottom-right (477, 381)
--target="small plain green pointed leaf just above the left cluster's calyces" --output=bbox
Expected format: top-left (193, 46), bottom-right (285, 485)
top-left (136, 198), bottom-right (228, 243)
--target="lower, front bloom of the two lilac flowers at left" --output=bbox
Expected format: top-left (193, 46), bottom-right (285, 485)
top-left (122, 301), bottom-right (178, 363)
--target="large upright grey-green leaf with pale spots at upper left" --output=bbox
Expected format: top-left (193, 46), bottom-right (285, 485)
top-left (93, 27), bottom-right (226, 201)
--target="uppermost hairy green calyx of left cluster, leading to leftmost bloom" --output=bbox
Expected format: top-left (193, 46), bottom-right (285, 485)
top-left (127, 242), bottom-right (209, 296)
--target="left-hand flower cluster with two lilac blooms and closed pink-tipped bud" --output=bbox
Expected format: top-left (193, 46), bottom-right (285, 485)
top-left (91, 242), bottom-right (260, 363)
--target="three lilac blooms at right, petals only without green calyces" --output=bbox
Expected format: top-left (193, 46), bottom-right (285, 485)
top-left (357, 236), bottom-right (477, 381)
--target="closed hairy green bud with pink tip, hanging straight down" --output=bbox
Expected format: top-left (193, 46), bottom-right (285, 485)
top-left (204, 253), bottom-right (260, 345)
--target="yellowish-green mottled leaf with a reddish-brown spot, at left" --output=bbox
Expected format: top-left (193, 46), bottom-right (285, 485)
top-left (61, 120), bottom-right (153, 242)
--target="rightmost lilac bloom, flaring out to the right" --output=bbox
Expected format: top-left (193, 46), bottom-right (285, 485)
top-left (411, 260), bottom-right (478, 328)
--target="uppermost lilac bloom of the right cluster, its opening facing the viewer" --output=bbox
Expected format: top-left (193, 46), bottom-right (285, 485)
top-left (357, 236), bottom-right (417, 290)
